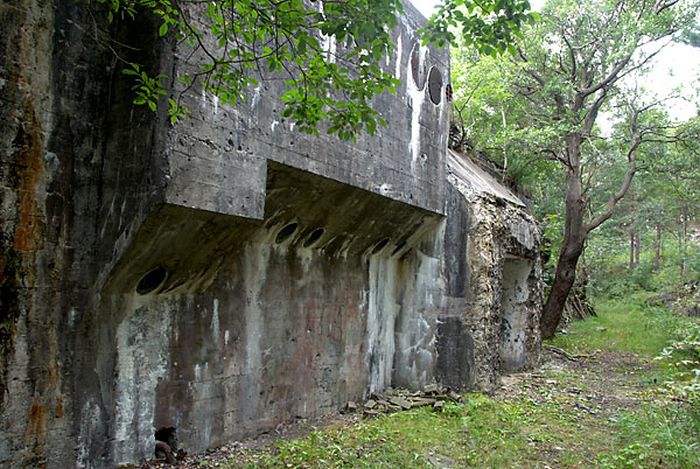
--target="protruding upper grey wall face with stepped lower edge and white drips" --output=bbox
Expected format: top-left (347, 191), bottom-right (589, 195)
top-left (166, 2), bottom-right (449, 218)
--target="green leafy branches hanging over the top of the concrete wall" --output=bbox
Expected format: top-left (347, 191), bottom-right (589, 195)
top-left (105, 0), bottom-right (410, 139)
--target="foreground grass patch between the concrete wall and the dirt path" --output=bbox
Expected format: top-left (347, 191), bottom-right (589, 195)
top-left (232, 393), bottom-right (605, 468)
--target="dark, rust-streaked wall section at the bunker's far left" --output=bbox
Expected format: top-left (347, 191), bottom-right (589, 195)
top-left (0, 0), bottom-right (172, 467)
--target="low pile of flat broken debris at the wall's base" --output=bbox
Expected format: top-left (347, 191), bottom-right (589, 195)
top-left (345, 384), bottom-right (462, 417)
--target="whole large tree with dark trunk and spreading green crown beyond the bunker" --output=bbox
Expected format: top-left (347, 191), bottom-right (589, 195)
top-left (454, 0), bottom-right (698, 337)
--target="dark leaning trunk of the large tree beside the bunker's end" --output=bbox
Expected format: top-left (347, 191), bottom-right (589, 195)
top-left (540, 135), bottom-right (586, 339)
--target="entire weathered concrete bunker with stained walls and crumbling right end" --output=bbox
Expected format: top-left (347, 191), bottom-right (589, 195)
top-left (0, 0), bottom-right (541, 468)
